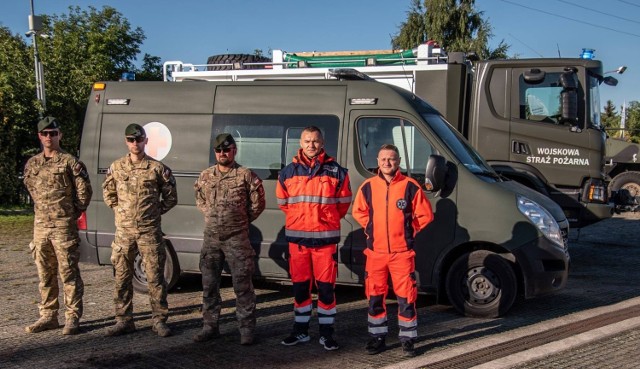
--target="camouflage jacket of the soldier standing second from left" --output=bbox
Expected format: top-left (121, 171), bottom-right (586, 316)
top-left (102, 155), bottom-right (178, 228)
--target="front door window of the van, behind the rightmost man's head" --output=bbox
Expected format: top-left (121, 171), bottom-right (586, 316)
top-left (356, 117), bottom-right (434, 183)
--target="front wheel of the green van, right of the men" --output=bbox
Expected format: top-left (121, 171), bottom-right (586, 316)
top-left (446, 250), bottom-right (518, 318)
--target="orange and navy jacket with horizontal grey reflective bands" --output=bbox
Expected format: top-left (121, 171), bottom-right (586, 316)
top-left (276, 149), bottom-right (351, 247)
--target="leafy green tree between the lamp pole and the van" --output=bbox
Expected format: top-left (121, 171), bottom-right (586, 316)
top-left (39, 6), bottom-right (154, 154)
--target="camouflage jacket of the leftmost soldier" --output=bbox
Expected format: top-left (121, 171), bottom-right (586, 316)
top-left (24, 151), bottom-right (93, 228)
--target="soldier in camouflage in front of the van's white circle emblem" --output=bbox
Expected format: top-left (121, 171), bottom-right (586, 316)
top-left (102, 123), bottom-right (178, 337)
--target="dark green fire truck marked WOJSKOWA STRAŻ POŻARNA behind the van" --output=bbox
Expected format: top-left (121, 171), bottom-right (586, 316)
top-left (164, 43), bottom-right (617, 227)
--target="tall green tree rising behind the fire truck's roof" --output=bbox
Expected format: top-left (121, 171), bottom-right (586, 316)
top-left (392, 0), bottom-right (509, 59)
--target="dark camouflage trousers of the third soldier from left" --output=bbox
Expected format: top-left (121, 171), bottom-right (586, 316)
top-left (200, 229), bottom-right (256, 333)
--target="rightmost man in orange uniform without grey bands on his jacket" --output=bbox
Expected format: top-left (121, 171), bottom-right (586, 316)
top-left (352, 145), bottom-right (433, 357)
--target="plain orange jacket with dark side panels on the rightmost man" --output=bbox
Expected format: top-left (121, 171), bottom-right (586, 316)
top-left (351, 170), bottom-right (433, 254)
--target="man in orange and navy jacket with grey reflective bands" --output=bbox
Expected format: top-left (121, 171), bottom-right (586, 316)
top-left (276, 126), bottom-right (351, 350)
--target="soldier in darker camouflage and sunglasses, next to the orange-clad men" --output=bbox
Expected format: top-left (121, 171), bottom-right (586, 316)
top-left (193, 133), bottom-right (265, 345)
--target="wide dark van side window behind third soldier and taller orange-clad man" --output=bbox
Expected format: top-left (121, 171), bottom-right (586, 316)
top-left (209, 114), bottom-right (340, 180)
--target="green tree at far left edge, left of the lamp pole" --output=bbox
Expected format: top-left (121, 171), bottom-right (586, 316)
top-left (0, 27), bottom-right (38, 205)
